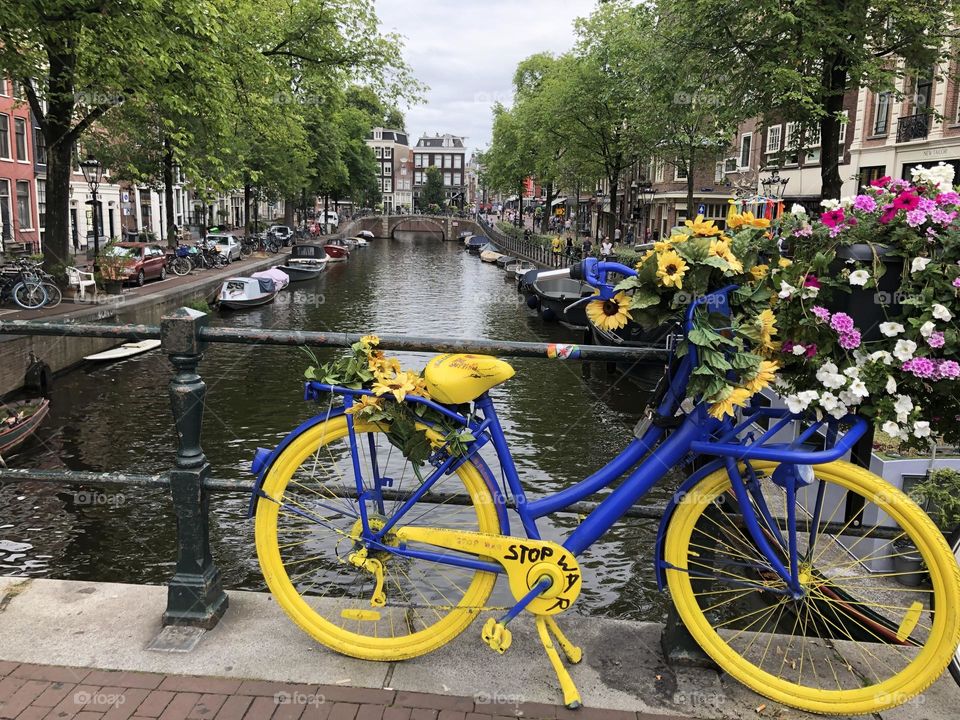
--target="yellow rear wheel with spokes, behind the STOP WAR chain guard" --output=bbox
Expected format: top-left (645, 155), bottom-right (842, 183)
top-left (255, 417), bottom-right (501, 660)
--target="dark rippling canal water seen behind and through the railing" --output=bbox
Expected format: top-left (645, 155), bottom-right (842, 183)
top-left (0, 235), bottom-right (667, 620)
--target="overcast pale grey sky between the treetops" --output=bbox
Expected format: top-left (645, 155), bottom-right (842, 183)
top-left (375, 0), bottom-right (596, 157)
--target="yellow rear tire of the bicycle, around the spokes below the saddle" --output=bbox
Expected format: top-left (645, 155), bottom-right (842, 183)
top-left (255, 417), bottom-right (501, 661)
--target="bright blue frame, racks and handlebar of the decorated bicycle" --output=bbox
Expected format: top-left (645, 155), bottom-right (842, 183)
top-left (257, 258), bottom-right (867, 596)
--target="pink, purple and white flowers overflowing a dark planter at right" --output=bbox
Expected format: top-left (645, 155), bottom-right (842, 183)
top-left (776, 163), bottom-right (960, 448)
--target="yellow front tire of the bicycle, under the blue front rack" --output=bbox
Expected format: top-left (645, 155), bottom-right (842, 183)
top-left (664, 462), bottom-right (960, 715)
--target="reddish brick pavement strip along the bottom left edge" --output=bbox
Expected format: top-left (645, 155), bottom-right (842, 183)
top-left (0, 661), bottom-right (667, 720)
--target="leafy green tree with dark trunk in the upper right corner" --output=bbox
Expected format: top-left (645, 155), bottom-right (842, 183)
top-left (676, 0), bottom-right (957, 198)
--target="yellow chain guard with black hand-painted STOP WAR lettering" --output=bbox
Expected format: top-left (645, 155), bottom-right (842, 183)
top-left (396, 526), bottom-right (583, 615)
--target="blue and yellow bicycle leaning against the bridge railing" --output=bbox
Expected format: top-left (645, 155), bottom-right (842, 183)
top-left (251, 259), bottom-right (960, 714)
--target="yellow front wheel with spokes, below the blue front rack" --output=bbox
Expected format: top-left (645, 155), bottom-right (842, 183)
top-left (664, 462), bottom-right (960, 714)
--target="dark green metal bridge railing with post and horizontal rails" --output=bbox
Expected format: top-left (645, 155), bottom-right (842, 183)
top-left (0, 308), bottom-right (666, 628)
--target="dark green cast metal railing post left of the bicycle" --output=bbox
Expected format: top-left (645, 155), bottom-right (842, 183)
top-left (160, 308), bottom-right (228, 629)
